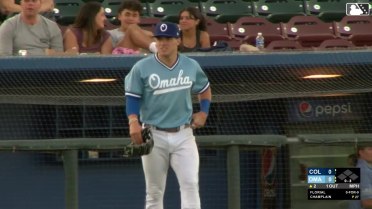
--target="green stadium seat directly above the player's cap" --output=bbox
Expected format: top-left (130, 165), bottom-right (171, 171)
top-left (148, 0), bottom-right (199, 23)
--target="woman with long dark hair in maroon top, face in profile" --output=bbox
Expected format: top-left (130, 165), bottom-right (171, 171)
top-left (63, 2), bottom-right (112, 54)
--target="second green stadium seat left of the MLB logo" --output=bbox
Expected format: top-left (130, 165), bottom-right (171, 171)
top-left (254, 0), bottom-right (306, 23)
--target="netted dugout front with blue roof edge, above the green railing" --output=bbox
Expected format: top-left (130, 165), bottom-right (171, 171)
top-left (0, 50), bottom-right (372, 138)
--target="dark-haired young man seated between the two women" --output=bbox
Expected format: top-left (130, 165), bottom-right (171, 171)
top-left (110, 0), bottom-right (157, 54)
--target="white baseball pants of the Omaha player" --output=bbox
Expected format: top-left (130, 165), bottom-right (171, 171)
top-left (142, 128), bottom-right (200, 209)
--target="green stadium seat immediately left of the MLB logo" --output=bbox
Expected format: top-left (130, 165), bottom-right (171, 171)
top-left (305, 0), bottom-right (354, 22)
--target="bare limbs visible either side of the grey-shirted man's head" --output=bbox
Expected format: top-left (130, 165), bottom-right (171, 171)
top-left (0, 0), bottom-right (54, 19)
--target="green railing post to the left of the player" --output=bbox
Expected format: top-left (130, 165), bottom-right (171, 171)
top-left (62, 150), bottom-right (79, 209)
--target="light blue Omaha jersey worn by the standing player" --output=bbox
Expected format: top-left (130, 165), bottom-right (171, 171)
top-left (125, 54), bottom-right (209, 128)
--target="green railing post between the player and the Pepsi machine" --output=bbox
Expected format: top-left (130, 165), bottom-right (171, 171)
top-left (226, 145), bottom-right (241, 209)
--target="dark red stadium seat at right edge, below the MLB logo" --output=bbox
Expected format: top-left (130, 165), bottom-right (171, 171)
top-left (336, 16), bottom-right (372, 46)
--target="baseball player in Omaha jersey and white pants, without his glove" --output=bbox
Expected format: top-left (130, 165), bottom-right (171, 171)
top-left (125, 22), bottom-right (212, 209)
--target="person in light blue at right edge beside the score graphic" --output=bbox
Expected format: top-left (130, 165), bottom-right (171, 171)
top-left (349, 145), bottom-right (372, 209)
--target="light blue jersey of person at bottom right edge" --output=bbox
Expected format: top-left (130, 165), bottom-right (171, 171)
top-left (349, 159), bottom-right (372, 209)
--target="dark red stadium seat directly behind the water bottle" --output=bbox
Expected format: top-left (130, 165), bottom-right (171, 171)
top-left (231, 17), bottom-right (284, 45)
